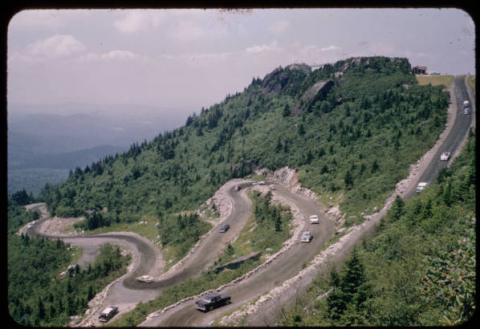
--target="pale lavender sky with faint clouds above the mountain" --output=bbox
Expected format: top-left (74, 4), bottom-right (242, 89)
top-left (7, 8), bottom-right (476, 117)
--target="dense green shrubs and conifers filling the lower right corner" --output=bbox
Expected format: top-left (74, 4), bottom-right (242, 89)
top-left (278, 132), bottom-right (476, 327)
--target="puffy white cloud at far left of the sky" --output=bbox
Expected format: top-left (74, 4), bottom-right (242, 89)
top-left (27, 34), bottom-right (86, 59)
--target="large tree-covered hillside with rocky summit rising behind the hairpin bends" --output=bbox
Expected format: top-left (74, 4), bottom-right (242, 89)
top-left (41, 57), bottom-right (448, 242)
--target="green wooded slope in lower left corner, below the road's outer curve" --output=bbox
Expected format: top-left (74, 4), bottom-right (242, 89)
top-left (7, 190), bottom-right (131, 327)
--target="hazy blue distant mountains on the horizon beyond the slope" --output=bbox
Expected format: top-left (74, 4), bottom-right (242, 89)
top-left (7, 103), bottom-right (188, 193)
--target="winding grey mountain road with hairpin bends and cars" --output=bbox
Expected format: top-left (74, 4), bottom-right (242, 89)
top-left (22, 76), bottom-right (475, 326)
